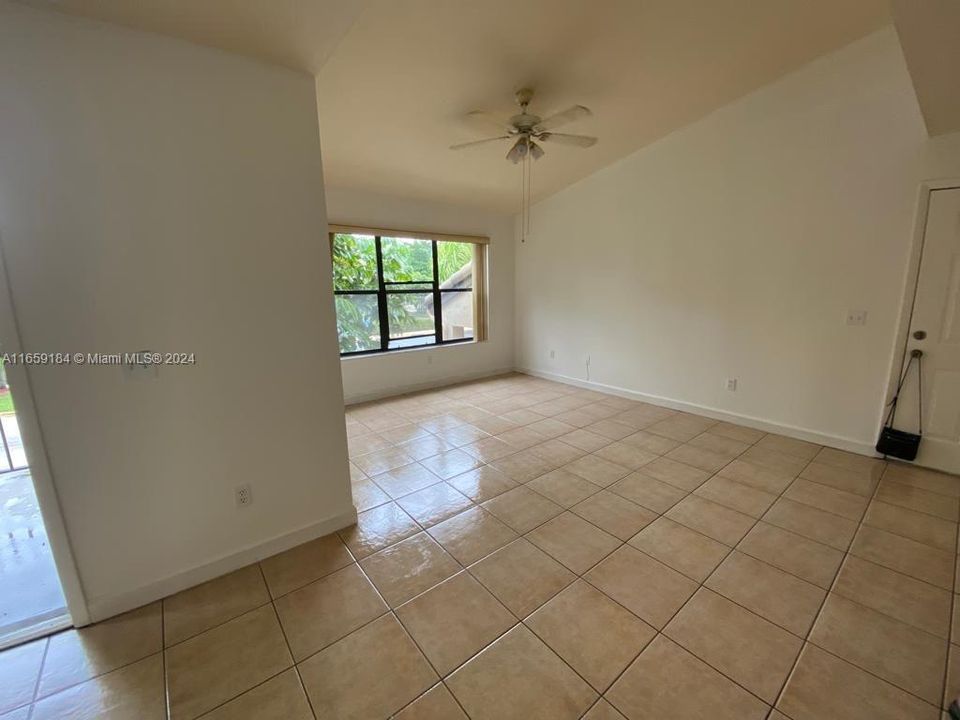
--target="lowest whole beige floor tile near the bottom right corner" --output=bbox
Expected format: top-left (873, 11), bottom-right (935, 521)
top-left (810, 594), bottom-right (946, 704)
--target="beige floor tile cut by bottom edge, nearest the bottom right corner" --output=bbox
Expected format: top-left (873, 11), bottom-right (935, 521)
top-left (777, 644), bottom-right (939, 720)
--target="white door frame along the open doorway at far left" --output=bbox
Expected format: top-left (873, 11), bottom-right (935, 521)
top-left (0, 237), bottom-right (90, 627)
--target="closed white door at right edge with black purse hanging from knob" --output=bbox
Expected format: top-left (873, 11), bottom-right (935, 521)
top-left (895, 188), bottom-right (960, 473)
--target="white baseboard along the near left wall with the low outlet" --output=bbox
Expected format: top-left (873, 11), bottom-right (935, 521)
top-left (87, 508), bottom-right (357, 622)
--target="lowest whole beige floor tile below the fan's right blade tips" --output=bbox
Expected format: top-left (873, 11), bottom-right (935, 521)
top-left (525, 580), bottom-right (656, 693)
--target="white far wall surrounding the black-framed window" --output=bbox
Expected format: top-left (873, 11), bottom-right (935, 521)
top-left (327, 187), bottom-right (514, 402)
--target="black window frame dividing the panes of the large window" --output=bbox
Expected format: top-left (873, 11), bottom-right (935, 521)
top-left (330, 232), bottom-right (478, 357)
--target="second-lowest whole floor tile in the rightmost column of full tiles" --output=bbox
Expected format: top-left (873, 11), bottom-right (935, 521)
top-left (833, 555), bottom-right (952, 639)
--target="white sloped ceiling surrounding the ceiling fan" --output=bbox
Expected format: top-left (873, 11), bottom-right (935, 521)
top-left (22, 0), bottom-right (892, 212)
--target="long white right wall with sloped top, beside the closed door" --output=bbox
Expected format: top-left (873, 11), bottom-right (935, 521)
top-left (516, 29), bottom-right (960, 451)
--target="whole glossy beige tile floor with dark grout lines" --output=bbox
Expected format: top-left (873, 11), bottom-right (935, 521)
top-left (0, 375), bottom-right (960, 720)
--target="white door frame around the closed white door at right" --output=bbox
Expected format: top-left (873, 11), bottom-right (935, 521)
top-left (874, 178), bottom-right (960, 464)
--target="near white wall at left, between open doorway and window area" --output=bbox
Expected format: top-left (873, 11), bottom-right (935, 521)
top-left (0, 3), bottom-right (352, 618)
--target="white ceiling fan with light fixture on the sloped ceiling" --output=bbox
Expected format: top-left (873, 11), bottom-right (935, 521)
top-left (450, 88), bottom-right (597, 164)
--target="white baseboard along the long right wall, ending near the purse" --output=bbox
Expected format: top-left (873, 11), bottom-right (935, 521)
top-left (516, 367), bottom-right (880, 457)
